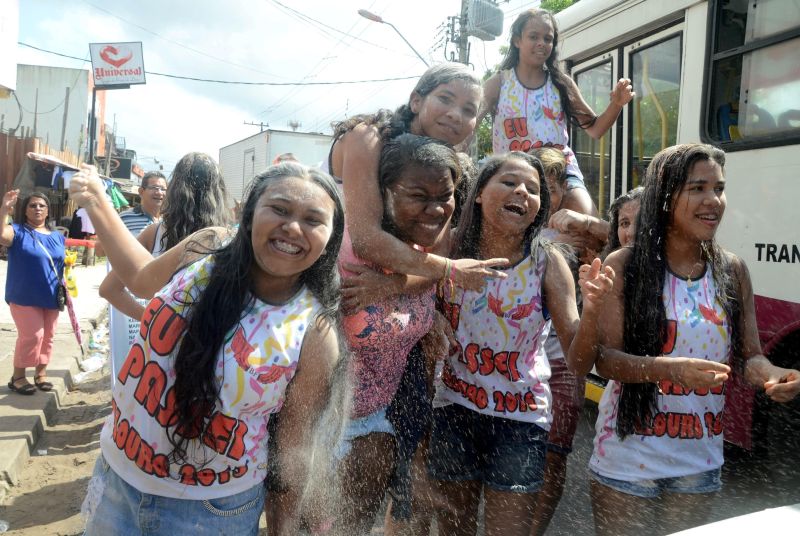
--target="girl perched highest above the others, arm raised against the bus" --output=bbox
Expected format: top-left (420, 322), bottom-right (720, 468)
top-left (478, 9), bottom-right (633, 214)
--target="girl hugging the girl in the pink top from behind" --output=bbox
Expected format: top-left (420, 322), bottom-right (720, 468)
top-left (328, 63), bottom-right (503, 298)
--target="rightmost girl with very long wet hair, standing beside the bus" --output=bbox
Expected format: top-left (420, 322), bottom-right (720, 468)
top-left (589, 144), bottom-right (800, 535)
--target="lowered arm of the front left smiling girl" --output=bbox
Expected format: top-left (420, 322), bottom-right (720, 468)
top-left (267, 321), bottom-right (344, 536)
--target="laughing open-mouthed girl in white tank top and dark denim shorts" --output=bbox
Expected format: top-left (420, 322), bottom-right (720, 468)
top-left (428, 152), bottom-right (613, 536)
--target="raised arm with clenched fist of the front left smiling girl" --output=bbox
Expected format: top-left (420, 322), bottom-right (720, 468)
top-left (69, 164), bottom-right (226, 299)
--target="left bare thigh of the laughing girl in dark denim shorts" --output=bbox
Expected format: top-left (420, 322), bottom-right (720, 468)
top-left (436, 480), bottom-right (482, 536)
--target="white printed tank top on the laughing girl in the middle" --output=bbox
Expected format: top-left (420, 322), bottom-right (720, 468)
top-left (436, 248), bottom-right (551, 430)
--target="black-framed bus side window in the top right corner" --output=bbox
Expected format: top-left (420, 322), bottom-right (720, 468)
top-left (706, 0), bottom-right (800, 147)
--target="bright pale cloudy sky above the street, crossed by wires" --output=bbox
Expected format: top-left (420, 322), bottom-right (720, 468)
top-left (17, 0), bottom-right (538, 171)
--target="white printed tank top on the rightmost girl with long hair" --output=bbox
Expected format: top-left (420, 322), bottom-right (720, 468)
top-left (589, 269), bottom-right (731, 481)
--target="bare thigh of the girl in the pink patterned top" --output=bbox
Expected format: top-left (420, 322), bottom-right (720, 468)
top-left (336, 433), bottom-right (394, 535)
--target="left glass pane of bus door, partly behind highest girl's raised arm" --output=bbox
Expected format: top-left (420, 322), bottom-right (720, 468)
top-left (572, 61), bottom-right (616, 214)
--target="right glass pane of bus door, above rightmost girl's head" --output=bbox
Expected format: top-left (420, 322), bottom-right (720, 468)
top-left (628, 34), bottom-right (681, 188)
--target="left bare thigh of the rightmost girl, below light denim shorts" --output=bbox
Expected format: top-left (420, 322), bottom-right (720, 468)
top-left (591, 480), bottom-right (660, 536)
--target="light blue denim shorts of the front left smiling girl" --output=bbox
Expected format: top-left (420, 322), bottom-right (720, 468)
top-left (81, 454), bottom-right (265, 536)
